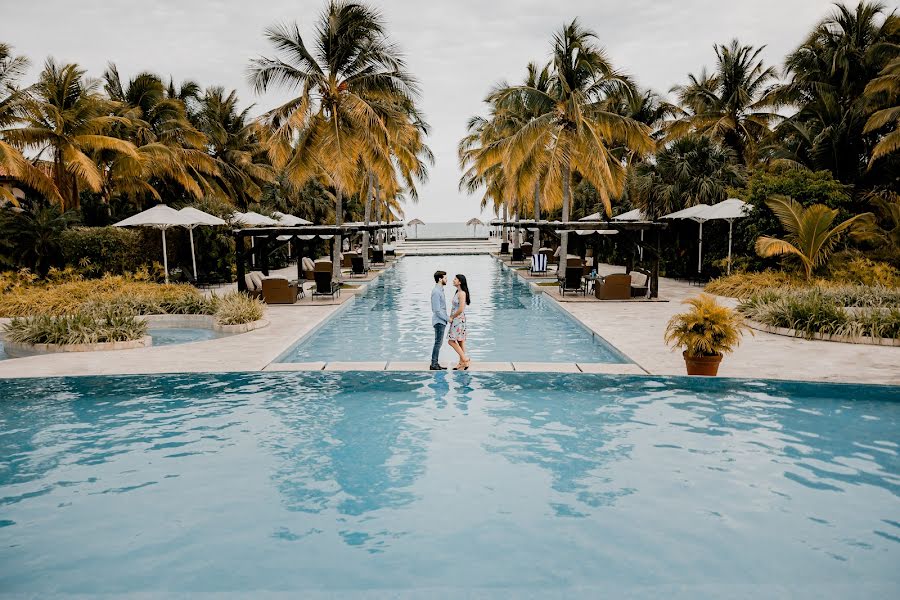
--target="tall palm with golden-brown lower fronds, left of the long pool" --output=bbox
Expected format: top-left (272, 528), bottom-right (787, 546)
top-left (250, 0), bottom-right (418, 277)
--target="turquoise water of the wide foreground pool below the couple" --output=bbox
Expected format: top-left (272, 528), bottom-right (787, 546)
top-left (0, 372), bottom-right (900, 598)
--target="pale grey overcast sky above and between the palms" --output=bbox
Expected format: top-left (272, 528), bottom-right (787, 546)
top-left (0, 0), bottom-right (832, 222)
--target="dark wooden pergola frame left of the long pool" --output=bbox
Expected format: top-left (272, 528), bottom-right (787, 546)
top-left (232, 222), bottom-right (403, 292)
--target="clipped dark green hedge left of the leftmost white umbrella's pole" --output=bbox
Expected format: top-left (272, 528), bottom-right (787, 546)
top-left (59, 227), bottom-right (149, 276)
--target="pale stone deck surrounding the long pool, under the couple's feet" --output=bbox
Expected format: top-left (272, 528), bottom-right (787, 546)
top-left (0, 254), bottom-right (900, 385)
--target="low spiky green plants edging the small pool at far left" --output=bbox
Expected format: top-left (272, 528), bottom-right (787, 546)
top-left (5, 307), bottom-right (147, 344)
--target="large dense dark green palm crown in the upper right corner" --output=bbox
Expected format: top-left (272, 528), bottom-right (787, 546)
top-left (769, 2), bottom-right (900, 184)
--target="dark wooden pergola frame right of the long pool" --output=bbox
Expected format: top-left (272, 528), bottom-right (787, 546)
top-left (491, 220), bottom-right (668, 298)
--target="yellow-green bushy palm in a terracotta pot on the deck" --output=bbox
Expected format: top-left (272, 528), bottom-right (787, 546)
top-left (665, 294), bottom-right (752, 376)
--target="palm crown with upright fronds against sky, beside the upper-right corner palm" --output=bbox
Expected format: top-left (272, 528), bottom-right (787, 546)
top-left (667, 40), bottom-right (776, 165)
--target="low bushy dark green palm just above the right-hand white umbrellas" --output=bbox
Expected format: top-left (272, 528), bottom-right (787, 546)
top-left (628, 135), bottom-right (746, 218)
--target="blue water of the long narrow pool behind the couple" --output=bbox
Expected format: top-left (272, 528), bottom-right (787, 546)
top-left (279, 256), bottom-right (630, 365)
